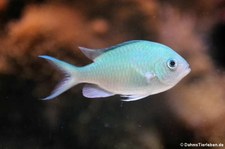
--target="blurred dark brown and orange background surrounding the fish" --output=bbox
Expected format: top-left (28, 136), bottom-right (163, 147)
top-left (0, 0), bottom-right (225, 149)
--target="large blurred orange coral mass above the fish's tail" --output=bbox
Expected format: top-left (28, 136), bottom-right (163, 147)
top-left (0, 4), bottom-right (98, 72)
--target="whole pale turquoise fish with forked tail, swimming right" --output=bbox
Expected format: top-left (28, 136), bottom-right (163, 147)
top-left (39, 40), bottom-right (191, 101)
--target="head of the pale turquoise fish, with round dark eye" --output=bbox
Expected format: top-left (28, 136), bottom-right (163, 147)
top-left (155, 49), bottom-right (191, 87)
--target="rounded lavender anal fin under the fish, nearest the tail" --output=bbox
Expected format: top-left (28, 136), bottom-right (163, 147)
top-left (82, 84), bottom-right (114, 98)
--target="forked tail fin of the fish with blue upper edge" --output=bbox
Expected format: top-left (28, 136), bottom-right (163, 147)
top-left (39, 55), bottom-right (79, 100)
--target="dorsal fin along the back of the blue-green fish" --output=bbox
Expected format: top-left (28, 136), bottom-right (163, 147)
top-left (78, 40), bottom-right (141, 60)
